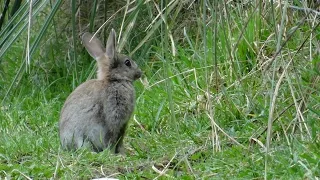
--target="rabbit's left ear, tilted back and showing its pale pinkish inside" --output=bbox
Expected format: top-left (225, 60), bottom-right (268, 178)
top-left (81, 33), bottom-right (104, 59)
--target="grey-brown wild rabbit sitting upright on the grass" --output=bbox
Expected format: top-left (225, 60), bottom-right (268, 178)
top-left (59, 29), bottom-right (142, 154)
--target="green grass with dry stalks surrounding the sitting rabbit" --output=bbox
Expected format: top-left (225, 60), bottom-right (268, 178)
top-left (0, 0), bottom-right (320, 179)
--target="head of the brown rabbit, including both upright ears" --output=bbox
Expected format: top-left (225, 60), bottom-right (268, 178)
top-left (82, 29), bottom-right (142, 82)
